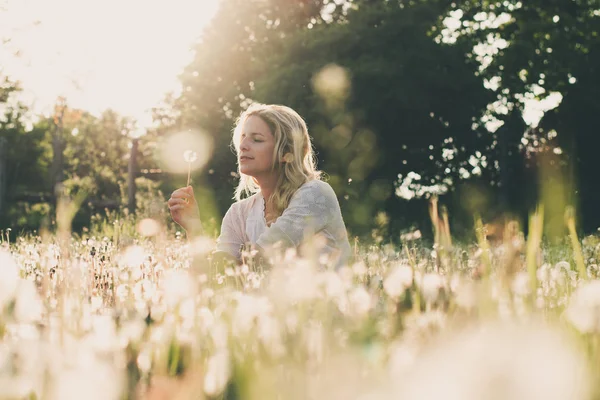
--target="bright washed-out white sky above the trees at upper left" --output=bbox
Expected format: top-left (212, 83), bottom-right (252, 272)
top-left (0, 0), bottom-right (218, 126)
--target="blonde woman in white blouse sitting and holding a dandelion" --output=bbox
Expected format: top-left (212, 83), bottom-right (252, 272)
top-left (168, 104), bottom-right (350, 265)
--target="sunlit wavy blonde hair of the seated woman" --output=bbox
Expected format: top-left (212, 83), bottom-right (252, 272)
top-left (232, 103), bottom-right (321, 216)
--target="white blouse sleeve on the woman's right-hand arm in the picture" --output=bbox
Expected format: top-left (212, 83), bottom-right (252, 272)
top-left (256, 182), bottom-right (339, 249)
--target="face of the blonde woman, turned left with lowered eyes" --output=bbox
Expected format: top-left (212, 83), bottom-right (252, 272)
top-left (238, 115), bottom-right (275, 178)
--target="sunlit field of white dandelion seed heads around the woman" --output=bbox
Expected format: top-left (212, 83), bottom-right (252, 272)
top-left (0, 206), bottom-right (600, 400)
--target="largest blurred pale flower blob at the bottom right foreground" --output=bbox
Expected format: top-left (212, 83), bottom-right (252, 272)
top-left (394, 324), bottom-right (590, 400)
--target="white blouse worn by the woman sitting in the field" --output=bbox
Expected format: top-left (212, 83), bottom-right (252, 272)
top-left (217, 180), bottom-right (351, 265)
